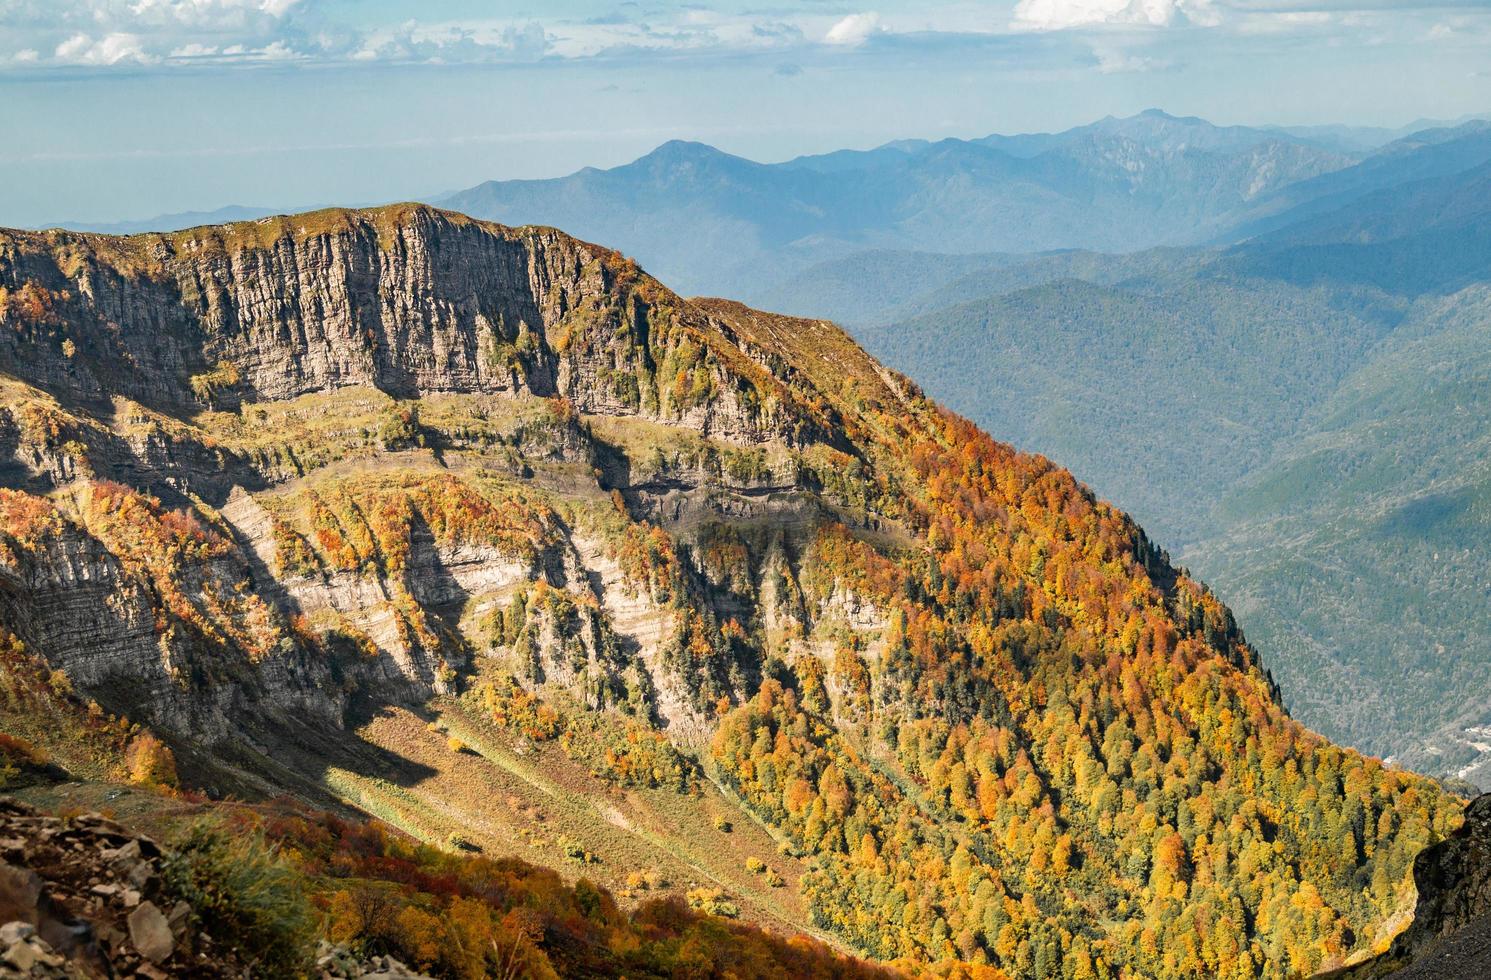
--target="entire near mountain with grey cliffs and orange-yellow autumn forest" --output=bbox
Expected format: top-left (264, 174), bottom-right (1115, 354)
top-left (0, 206), bottom-right (1458, 977)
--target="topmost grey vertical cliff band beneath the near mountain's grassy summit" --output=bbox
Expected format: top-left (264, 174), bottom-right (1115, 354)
top-left (0, 206), bottom-right (832, 442)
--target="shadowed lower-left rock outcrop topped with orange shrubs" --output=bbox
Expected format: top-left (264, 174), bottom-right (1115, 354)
top-left (0, 497), bottom-right (343, 738)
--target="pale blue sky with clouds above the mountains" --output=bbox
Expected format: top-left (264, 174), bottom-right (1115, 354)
top-left (0, 0), bottom-right (1491, 227)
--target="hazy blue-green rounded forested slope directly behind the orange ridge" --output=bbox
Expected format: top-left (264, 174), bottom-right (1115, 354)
top-left (856, 267), bottom-right (1400, 546)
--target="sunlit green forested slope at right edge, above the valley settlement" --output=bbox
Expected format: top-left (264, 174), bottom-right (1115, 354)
top-left (1187, 285), bottom-right (1491, 780)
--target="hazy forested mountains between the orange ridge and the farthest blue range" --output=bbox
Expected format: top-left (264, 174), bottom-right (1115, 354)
top-left (756, 122), bottom-right (1491, 782)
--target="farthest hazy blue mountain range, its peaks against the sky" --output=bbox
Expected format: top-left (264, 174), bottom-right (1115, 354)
top-left (440, 110), bottom-right (1355, 298)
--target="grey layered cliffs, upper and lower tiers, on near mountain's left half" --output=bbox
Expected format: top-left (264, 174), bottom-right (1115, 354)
top-left (0, 206), bottom-right (889, 738)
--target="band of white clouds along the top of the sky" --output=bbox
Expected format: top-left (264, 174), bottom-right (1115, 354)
top-left (0, 0), bottom-right (1467, 73)
